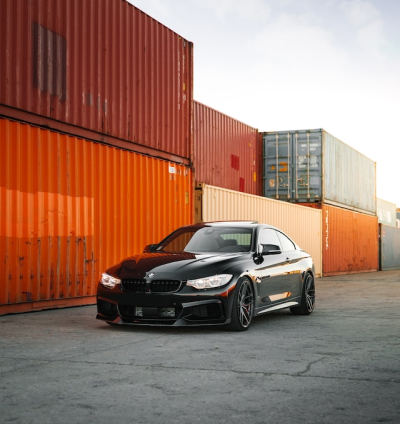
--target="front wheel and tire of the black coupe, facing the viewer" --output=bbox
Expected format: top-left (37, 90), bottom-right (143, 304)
top-left (226, 278), bottom-right (254, 331)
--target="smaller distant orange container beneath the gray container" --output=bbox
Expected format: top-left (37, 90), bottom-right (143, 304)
top-left (303, 203), bottom-right (379, 276)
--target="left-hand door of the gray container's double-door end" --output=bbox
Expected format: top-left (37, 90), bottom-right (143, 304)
top-left (264, 132), bottom-right (292, 201)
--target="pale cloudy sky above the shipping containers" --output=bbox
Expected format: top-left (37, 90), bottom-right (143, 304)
top-left (129, 0), bottom-right (400, 208)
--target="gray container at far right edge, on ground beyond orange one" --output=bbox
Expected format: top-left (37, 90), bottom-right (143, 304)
top-left (379, 224), bottom-right (400, 271)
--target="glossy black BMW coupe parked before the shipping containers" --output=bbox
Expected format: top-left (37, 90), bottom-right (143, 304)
top-left (96, 221), bottom-right (315, 331)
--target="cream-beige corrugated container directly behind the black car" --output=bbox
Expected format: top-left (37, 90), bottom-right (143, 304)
top-left (195, 184), bottom-right (322, 276)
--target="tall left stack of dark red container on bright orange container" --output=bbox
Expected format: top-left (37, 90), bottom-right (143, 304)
top-left (0, 0), bottom-right (194, 314)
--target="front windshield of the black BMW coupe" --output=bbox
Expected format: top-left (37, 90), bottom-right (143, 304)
top-left (156, 226), bottom-right (253, 253)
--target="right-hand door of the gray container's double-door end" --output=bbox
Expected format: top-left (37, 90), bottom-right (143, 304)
top-left (292, 130), bottom-right (322, 202)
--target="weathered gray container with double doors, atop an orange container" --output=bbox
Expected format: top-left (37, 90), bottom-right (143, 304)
top-left (263, 129), bottom-right (376, 215)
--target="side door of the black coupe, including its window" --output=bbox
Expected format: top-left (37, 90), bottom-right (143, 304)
top-left (256, 228), bottom-right (293, 307)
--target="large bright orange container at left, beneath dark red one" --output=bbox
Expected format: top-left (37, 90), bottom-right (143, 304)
top-left (0, 119), bottom-right (193, 314)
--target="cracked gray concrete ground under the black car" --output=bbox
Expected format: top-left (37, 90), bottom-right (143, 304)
top-left (0, 271), bottom-right (400, 424)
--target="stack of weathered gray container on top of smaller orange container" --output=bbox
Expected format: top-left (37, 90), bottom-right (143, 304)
top-left (263, 129), bottom-right (379, 275)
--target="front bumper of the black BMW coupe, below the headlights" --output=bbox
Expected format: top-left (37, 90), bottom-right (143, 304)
top-left (96, 284), bottom-right (236, 326)
